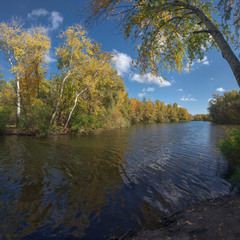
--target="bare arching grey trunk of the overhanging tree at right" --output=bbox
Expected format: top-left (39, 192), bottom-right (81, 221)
top-left (174, 1), bottom-right (240, 87)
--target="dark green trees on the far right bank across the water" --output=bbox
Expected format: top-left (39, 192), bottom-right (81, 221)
top-left (208, 90), bottom-right (240, 124)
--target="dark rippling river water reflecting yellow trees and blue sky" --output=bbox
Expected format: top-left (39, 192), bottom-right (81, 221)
top-left (0, 122), bottom-right (231, 240)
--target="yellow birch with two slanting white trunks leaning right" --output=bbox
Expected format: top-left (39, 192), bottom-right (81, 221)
top-left (50, 25), bottom-right (111, 129)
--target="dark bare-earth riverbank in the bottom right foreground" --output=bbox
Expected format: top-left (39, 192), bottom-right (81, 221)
top-left (127, 195), bottom-right (240, 240)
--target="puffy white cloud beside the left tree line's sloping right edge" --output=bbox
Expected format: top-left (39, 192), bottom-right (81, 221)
top-left (113, 49), bottom-right (132, 75)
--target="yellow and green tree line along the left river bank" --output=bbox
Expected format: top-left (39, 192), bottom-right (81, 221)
top-left (0, 21), bottom-right (190, 135)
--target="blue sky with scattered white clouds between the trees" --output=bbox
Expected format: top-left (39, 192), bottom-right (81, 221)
top-left (0, 0), bottom-right (239, 114)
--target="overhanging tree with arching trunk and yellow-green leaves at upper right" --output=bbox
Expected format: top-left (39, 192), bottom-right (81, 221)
top-left (89, 0), bottom-right (240, 86)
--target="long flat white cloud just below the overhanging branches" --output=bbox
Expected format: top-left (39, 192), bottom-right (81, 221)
top-left (131, 73), bottom-right (172, 87)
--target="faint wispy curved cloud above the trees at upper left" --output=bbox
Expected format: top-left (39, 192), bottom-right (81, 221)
top-left (27, 8), bottom-right (63, 33)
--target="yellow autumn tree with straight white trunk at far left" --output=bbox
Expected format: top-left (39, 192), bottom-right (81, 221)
top-left (0, 20), bottom-right (50, 123)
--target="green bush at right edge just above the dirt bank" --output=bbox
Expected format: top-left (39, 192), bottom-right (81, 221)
top-left (218, 129), bottom-right (240, 184)
